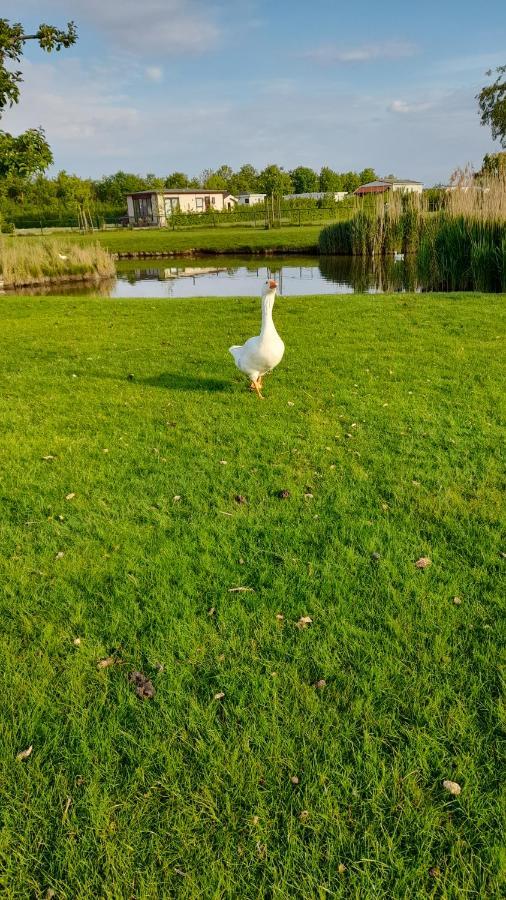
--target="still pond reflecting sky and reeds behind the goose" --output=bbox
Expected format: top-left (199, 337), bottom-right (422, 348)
top-left (5, 256), bottom-right (423, 298)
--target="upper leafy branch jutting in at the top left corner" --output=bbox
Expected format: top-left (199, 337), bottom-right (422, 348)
top-left (0, 19), bottom-right (77, 111)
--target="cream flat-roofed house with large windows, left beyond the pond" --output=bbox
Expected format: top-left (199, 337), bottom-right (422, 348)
top-left (127, 188), bottom-right (237, 227)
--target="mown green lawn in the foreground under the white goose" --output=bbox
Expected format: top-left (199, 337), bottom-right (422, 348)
top-left (0, 294), bottom-right (506, 900)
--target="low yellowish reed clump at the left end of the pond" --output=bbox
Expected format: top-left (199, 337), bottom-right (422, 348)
top-left (0, 238), bottom-right (115, 287)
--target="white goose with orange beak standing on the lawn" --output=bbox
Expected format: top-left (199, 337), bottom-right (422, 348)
top-left (229, 278), bottom-right (285, 399)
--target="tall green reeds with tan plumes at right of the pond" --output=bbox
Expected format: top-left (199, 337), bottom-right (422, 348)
top-left (319, 170), bottom-right (506, 291)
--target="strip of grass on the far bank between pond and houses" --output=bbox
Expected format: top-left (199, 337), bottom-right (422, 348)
top-left (68, 223), bottom-right (322, 254)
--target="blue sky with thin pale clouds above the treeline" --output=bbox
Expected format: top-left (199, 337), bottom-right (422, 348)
top-left (1, 0), bottom-right (506, 186)
